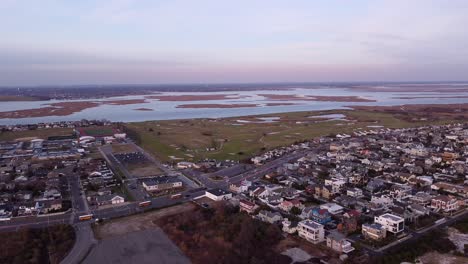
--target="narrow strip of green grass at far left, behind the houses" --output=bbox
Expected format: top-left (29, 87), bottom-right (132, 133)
top-left (0, 128), bottom-right (73, 141)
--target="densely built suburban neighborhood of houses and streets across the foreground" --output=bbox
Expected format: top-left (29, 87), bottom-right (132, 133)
top-left (0, 120), bottom-right (468, 261)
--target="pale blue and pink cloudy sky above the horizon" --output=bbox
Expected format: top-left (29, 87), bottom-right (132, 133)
top-left (0, 0), bottom-right (468, 86)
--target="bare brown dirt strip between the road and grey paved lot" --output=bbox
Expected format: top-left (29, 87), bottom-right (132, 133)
top-left (94, 203), bottom-right (195, 239)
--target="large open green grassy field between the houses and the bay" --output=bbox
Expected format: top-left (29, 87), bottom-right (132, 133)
top-left (127, 110), bottom-right (459, 161)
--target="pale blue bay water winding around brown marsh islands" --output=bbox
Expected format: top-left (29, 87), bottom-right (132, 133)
top-left (0, 85), bottom-right (468, 125)
